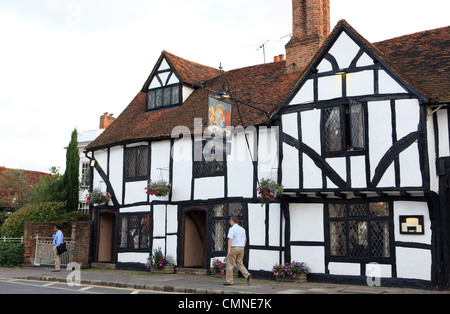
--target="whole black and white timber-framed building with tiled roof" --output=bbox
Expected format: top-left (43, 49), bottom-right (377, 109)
top-left (86, 0), bottom-right (450, 288)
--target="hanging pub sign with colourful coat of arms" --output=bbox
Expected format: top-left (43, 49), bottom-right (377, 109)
top-left (206, 96), bottom-right (233, 154)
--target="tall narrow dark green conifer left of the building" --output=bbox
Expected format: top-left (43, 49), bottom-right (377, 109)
top-left (63, 129), bottom-right (80, 211)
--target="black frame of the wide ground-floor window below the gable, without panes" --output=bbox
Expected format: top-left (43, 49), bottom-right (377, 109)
top-left (325, 200), bottom-right (395, 264)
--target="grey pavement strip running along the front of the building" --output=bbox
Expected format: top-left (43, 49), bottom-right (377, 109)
top-left (0, 267), bottom-right (450, 295)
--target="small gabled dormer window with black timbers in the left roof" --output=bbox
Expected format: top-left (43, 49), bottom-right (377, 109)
top-left (147, 59), bottom-right (182, 110)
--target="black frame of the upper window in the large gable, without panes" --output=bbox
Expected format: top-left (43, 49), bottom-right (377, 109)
top-left (321, 101), bottom-right (368, 157)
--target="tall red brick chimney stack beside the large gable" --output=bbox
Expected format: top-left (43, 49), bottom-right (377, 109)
top-left (286, 0), bottom-right (330, 69)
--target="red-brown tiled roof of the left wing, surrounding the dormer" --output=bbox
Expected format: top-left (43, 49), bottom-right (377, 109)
top-left (87, 59), bottom-right (300, 150)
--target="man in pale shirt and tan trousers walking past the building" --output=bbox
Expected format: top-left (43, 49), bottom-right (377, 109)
top-left (224, 216), bottom-right (252, 286)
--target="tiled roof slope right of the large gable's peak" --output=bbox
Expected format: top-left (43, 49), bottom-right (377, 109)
top-left (374, 26), bottom-right (450, 102)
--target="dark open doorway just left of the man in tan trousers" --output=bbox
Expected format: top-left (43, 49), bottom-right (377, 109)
top-left (181, 207), bottom-right (208, 268)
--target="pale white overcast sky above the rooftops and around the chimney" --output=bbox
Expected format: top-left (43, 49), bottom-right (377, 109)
top-left (0, 0), bottom-right (450, 172)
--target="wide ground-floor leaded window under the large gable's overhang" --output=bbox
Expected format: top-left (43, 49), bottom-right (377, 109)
top-left (328, 202), bottom-right (392, 261)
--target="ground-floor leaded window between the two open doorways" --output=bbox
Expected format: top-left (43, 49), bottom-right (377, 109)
top-left (119, 214), bottom-right (150, 251)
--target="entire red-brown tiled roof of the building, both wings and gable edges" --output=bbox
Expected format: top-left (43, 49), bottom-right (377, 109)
top-left (87, 20), bottom-right (450, 150)
